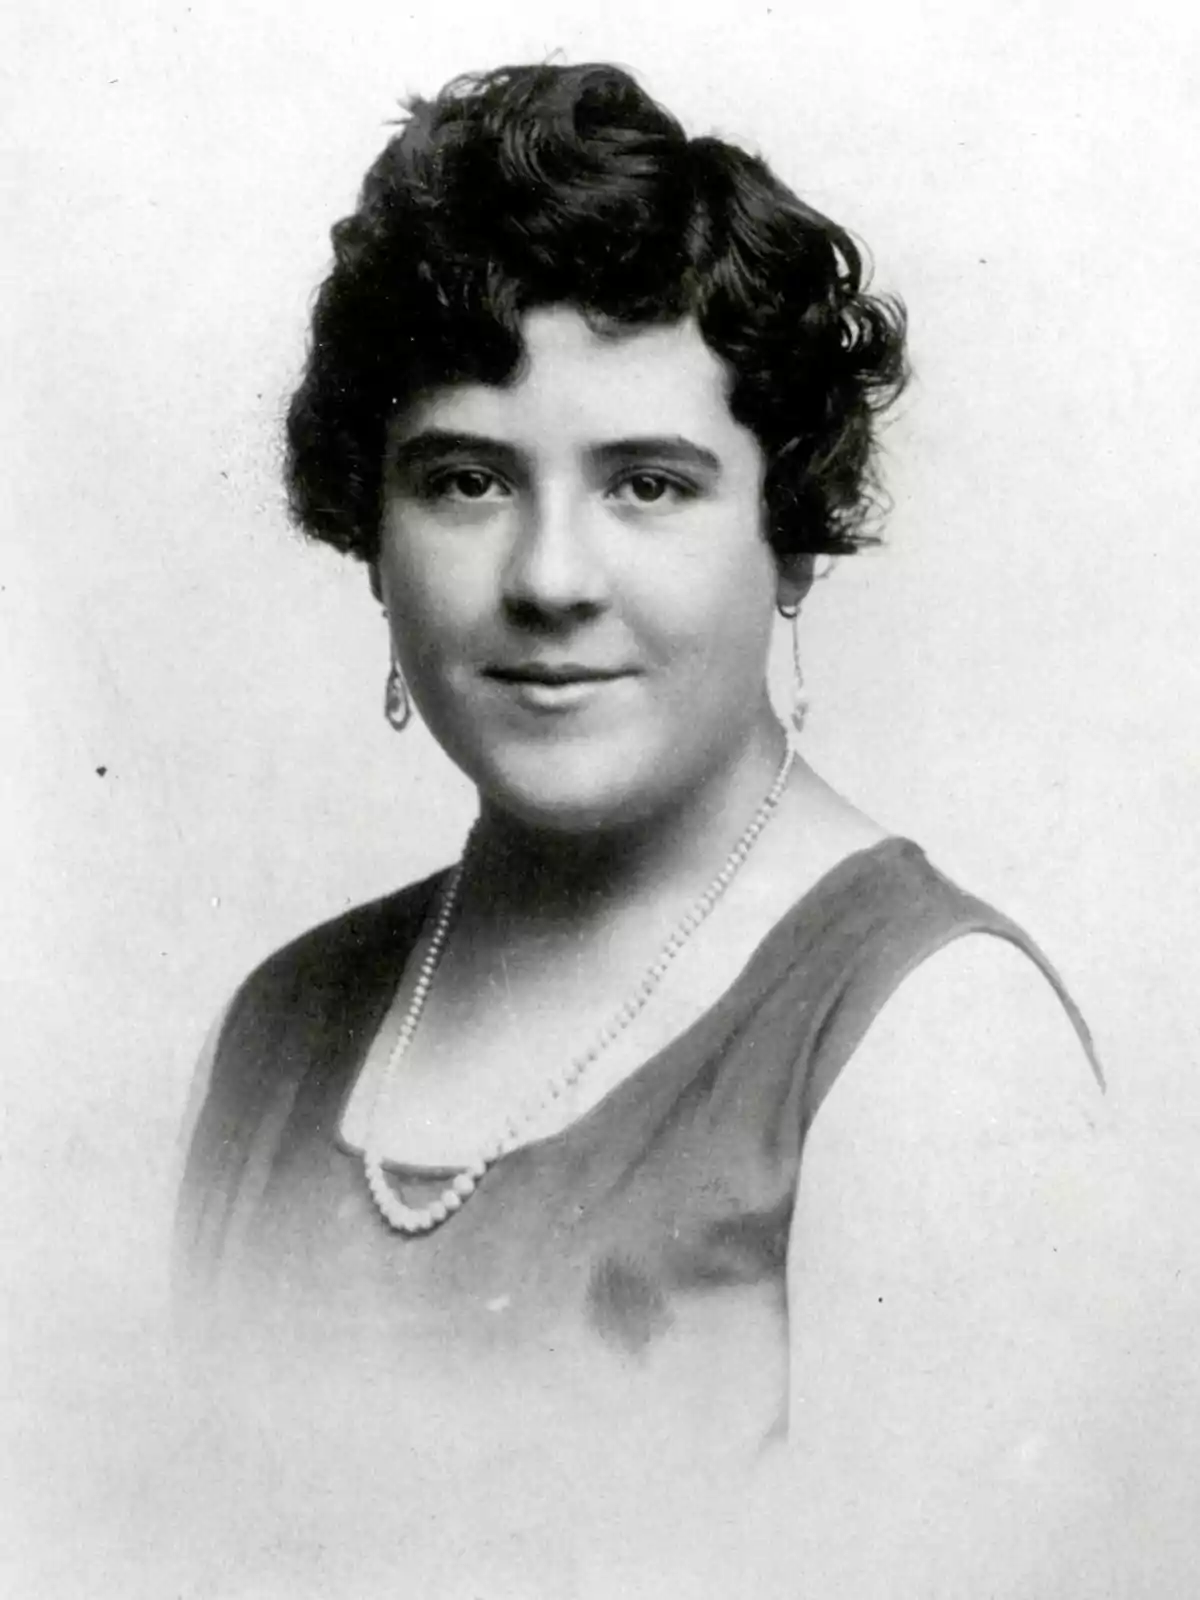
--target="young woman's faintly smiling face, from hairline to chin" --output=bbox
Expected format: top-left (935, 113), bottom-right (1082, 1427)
top-left (379, 307), bottom-right (790, 829)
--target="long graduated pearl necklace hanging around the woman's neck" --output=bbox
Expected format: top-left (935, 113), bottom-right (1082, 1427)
top-left (363, 742), bottom-right (795, 1234)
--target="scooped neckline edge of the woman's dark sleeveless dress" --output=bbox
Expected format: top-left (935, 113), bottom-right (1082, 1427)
top-left (334, 834), bottom-right (925, 1182)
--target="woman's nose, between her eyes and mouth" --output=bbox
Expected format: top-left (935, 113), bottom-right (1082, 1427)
top-left (502, 491), bottom-right (608, 627)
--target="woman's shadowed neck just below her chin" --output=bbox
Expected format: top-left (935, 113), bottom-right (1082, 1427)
top-left (464, 720), bottom-right (786, 928)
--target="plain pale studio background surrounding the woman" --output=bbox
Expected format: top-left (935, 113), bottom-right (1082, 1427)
top-left (0, 0), bottom-right (1200, 1592)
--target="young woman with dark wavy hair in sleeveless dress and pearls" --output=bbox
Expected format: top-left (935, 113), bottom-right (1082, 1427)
top-left (179, 56), bottom-right (1107, 1595)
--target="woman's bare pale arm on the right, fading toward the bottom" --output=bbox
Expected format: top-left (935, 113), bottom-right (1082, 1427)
top-left (789, 934), bottom-right (1114, 1595)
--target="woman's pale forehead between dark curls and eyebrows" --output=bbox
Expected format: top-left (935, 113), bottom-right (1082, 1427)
top-left (397, 306), bottom-right (757, 454)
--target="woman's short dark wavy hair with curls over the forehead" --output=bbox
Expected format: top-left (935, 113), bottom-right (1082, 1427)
top-left (286, 66), bottom-right (907, 566)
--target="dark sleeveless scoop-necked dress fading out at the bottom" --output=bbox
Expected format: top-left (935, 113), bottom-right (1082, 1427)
top-left (178, 838), bottom-right (1094, 1437)
